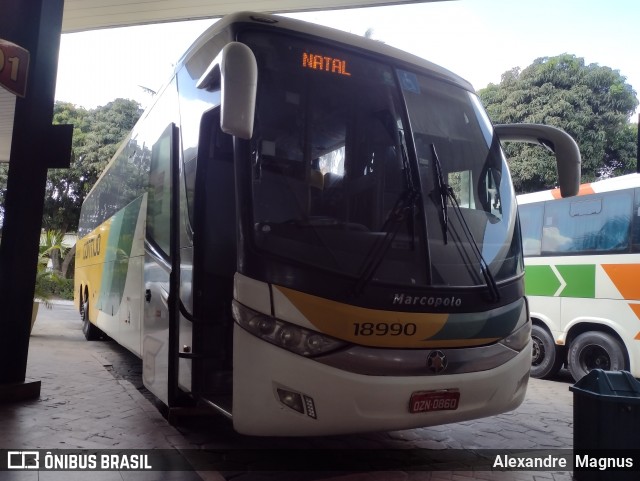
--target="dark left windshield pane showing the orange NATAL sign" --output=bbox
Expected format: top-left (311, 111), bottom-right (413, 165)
top-left (242, 33), bottom-right (427, 285)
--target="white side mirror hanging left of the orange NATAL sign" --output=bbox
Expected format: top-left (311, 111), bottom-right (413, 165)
top-left (196, 42), bottom-right (258, 139)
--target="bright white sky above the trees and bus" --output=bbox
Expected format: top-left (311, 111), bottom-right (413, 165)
top-left (56, 0), bottom-right (640, 121)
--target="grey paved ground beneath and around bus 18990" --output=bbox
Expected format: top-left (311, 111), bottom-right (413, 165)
top-left (0, 305), bottom-right (573, 481)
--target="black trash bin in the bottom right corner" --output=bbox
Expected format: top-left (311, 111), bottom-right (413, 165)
top-left (569, 369), bottom-right (640, 481)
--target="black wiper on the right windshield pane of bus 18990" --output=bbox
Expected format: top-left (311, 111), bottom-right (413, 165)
top-left (431, 144), bottom-right (500, 302)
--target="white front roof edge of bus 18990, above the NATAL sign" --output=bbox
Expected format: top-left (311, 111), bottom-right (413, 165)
top-left (176, 12), bottom-right (475, 92)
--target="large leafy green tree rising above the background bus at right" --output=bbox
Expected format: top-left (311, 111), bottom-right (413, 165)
top-left (478, 54), bottom-right (638, 193)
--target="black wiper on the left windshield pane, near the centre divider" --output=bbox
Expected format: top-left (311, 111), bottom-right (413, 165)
top-left (353, 130), bottom-right (420, 296)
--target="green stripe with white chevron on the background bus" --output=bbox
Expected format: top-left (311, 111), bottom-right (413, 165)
top-left (525, 264), bottom-right (596, 298)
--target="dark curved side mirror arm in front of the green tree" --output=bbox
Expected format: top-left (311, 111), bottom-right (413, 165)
top-left (494, 124), bottom-right (581, 197)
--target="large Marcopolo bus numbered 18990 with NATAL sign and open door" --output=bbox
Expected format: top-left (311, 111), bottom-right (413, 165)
top-left (75, 13), bottom-right (580, 436)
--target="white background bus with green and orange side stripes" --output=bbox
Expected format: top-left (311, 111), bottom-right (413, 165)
top-left (518, 174), bottom-right (640, 381)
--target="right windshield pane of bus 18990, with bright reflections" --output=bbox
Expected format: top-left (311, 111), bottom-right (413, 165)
top-left (398, 70), bottom-right (523, 286)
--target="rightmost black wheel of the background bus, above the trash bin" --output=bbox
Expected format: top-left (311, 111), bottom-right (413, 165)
top-left (568, 331), bottom-right (626, 382)
